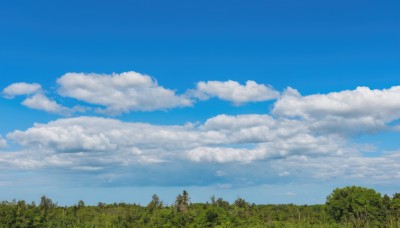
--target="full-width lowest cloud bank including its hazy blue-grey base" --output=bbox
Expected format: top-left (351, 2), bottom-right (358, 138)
top-left (0, 111), bottom-right (400, 185)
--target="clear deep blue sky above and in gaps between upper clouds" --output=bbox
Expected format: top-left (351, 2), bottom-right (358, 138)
top-left (0, 0), bottom-right (400, 128)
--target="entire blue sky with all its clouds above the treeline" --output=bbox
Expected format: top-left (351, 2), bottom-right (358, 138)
top-left (0, 0), bottom-right (400, 205)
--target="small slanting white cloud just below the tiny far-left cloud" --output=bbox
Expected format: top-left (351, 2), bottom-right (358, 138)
top-left (22, 93), bottom-right (70, 115)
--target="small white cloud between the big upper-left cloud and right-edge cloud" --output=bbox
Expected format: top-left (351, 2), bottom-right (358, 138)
top-left (192, 80), bottom-right (279, 105)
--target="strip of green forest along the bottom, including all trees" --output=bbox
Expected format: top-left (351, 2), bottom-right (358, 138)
top-left (0, 186), bottom-right (400, 227)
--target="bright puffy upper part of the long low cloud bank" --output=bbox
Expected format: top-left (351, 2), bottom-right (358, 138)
top-left (7, 115), bottom-right (345, 167)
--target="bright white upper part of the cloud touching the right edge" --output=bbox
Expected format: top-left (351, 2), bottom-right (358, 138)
top-left (273, 86), bottom-right (400, 123)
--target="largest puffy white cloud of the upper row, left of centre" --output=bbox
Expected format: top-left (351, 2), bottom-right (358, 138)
top-left (57, 72), bottom-right (192, 114)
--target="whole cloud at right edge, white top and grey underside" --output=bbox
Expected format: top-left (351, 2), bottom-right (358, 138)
top-left (273, 86), bottom-right (400, 134)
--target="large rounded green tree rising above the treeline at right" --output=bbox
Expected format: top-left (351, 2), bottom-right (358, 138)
top-left (326, 186), bottom-right (384, 227)
